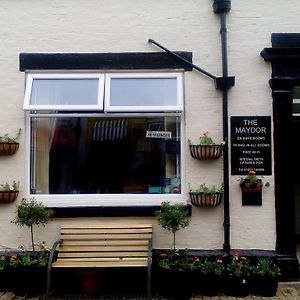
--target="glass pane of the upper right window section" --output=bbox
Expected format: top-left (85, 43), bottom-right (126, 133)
top-left (110, 78), bottom-right (177, 106)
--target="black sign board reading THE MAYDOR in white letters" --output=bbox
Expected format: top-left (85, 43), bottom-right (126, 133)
top-left (231, 116), bottom-right (272, 175)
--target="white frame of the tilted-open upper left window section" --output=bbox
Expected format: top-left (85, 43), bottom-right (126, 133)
top-left (23, 73), bottom-right (104, 111)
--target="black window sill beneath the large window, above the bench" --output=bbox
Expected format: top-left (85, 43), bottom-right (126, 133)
top-left (48, 204), bottom-right (192, 218)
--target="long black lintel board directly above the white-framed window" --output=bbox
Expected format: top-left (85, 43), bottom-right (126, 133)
top-left (19, 51), bottom-right (192, 72)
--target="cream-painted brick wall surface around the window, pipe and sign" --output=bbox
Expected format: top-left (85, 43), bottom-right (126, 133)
top-left (0, 0), bottom-right (300, 253)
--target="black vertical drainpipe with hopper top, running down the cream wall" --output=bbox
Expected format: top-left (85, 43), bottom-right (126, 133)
top-left (213, 0), bottom-right (231, 253)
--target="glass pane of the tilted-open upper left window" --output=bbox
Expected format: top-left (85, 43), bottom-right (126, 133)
top-left (30, 79), bottom-right (99, 105)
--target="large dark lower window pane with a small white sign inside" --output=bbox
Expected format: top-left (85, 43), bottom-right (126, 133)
top-left (31, 117), bottom-right (181, 194)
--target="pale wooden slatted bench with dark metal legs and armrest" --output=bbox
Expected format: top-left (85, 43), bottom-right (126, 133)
top-left (46, 224), bottom-right (152, 299)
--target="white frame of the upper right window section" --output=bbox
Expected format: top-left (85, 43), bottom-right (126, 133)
top-left (104, 72), bottom-right (183, 112)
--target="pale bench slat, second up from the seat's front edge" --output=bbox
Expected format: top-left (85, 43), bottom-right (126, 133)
top-left (58, 252), bottom-right (148, 258)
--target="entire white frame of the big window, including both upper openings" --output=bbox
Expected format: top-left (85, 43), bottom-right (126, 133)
top-left (24, 72), bottom-right (188, 209)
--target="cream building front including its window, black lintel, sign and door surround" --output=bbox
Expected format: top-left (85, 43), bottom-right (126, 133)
top-left (0, 0), bottom-right (300, 276)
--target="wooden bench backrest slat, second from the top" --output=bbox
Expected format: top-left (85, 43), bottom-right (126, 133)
top-left (61, 233), bottom-right (152, 240)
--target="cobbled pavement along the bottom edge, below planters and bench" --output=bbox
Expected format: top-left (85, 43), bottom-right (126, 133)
top-left (0, 282), bottom-right (300, 300)
